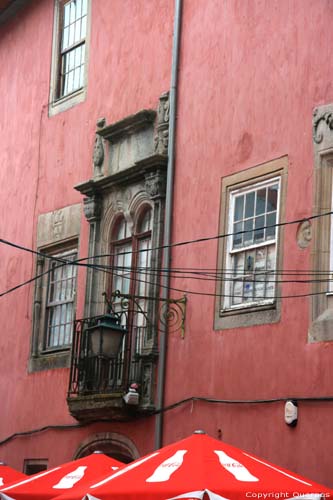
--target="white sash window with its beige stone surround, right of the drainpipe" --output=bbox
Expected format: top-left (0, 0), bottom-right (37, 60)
top-left (214, 156), bottom-right (288, 330)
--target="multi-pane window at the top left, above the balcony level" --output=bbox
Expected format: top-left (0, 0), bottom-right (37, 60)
top-left (58, 0), bottom-right (88, 98)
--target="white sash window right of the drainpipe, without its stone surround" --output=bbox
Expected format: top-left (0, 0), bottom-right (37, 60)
top-left (224, 178), bottom-right (280, 308)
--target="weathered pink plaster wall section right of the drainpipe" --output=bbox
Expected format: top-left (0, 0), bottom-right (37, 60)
top-left (165, 0), bottom-right (333, 485)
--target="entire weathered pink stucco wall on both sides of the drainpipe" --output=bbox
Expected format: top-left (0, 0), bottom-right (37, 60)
top-left (0, 0), bottom-right (333, 486)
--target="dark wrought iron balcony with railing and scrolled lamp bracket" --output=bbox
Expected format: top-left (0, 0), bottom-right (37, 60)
top-left (67, 292), bottom-right (186, 421)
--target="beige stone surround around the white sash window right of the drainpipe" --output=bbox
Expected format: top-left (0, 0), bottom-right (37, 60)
top-left (214, 156), bottom-right (288, 330)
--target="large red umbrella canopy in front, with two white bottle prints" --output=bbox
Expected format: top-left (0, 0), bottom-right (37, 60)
top-left (76, 431), bottom-right (333, 500)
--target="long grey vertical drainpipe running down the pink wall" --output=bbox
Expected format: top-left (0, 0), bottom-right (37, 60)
top-left (155, 0), bottom-right (182, 449)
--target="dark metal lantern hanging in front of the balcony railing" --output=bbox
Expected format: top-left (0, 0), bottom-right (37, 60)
top-left (87, 314), bottom-right (127, 358)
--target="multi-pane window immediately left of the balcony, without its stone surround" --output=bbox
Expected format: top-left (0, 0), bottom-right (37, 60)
top-left (45, 250), bottom-right (77, 349)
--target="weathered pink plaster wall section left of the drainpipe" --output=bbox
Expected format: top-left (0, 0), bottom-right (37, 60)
top-left (0, 0), bottom-right (173, 469)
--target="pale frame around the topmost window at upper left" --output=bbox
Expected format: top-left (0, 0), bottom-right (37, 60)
top-left (49, 0), bottom-right (91, 116)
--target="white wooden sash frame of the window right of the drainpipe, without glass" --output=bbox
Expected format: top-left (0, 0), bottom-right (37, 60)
top-left (222, 176), bottom-right (281, 311)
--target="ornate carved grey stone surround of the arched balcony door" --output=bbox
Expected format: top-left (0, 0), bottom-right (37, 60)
top-left (68, 93), bottom-right (169, 419)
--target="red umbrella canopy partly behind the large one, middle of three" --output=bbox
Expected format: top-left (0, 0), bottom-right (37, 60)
top-left (0, 453), bottom-right (124, 500)
